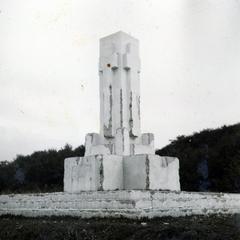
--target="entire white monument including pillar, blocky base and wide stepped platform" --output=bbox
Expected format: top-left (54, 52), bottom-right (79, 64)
top-left (0, 32), bottom-right (240, 219)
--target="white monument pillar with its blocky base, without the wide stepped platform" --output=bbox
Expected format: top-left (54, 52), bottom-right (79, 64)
top-left (64, 32), bottom-right (180, 193)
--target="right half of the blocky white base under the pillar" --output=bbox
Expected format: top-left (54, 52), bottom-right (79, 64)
top-left (123, 154), bottom-right (180, 191)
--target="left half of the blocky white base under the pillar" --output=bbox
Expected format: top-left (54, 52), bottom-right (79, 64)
top-left (64, 155), bottom-right (123, 193)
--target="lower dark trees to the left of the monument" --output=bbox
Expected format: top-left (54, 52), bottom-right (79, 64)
top-left (0, 144), bottom-right (85, 193)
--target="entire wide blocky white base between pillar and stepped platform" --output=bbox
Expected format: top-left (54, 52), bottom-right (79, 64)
top-left (64, 154), bottom-right (180, 193)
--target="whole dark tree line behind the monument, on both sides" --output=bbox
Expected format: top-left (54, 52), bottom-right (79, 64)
top-left (0, 124), bottom-right (240, 193)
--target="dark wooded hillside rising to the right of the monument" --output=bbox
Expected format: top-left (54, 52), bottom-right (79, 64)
top-left (156, 124), bottom-right (240, 193)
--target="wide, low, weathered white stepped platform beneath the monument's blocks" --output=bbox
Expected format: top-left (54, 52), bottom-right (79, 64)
top-left (0, 190), bottom-right (240, 218)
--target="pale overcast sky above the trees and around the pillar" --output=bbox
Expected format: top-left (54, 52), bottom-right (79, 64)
top-left (0, 0), bottom-right (240, 161)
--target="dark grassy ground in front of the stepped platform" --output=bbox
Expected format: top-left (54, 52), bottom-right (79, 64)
top-left (0, 214), bottom-right (240, 240)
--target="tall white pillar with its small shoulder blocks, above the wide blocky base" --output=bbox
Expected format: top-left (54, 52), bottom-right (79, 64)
top-left (85, 32), bottom-right (154, 156)
